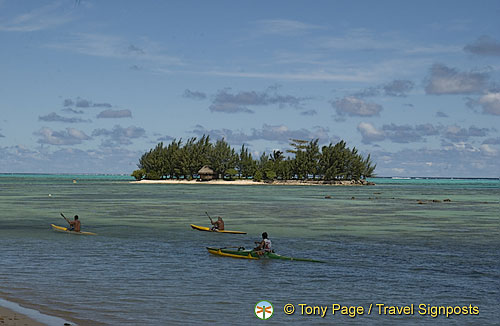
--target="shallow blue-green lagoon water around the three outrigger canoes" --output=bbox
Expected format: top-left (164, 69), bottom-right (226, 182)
top-left (0, 175), bottom-right (500, 325)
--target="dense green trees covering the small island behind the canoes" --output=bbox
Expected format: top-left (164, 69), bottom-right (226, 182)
top-left (132, 135), bottom-right (376, 181)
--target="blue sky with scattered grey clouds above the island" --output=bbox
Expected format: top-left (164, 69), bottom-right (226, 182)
top-left (0, 0), bottom-right (500, 177)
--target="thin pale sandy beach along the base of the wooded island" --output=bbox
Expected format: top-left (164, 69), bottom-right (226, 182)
top-left (130, 180), bottom-right (374, 186)
